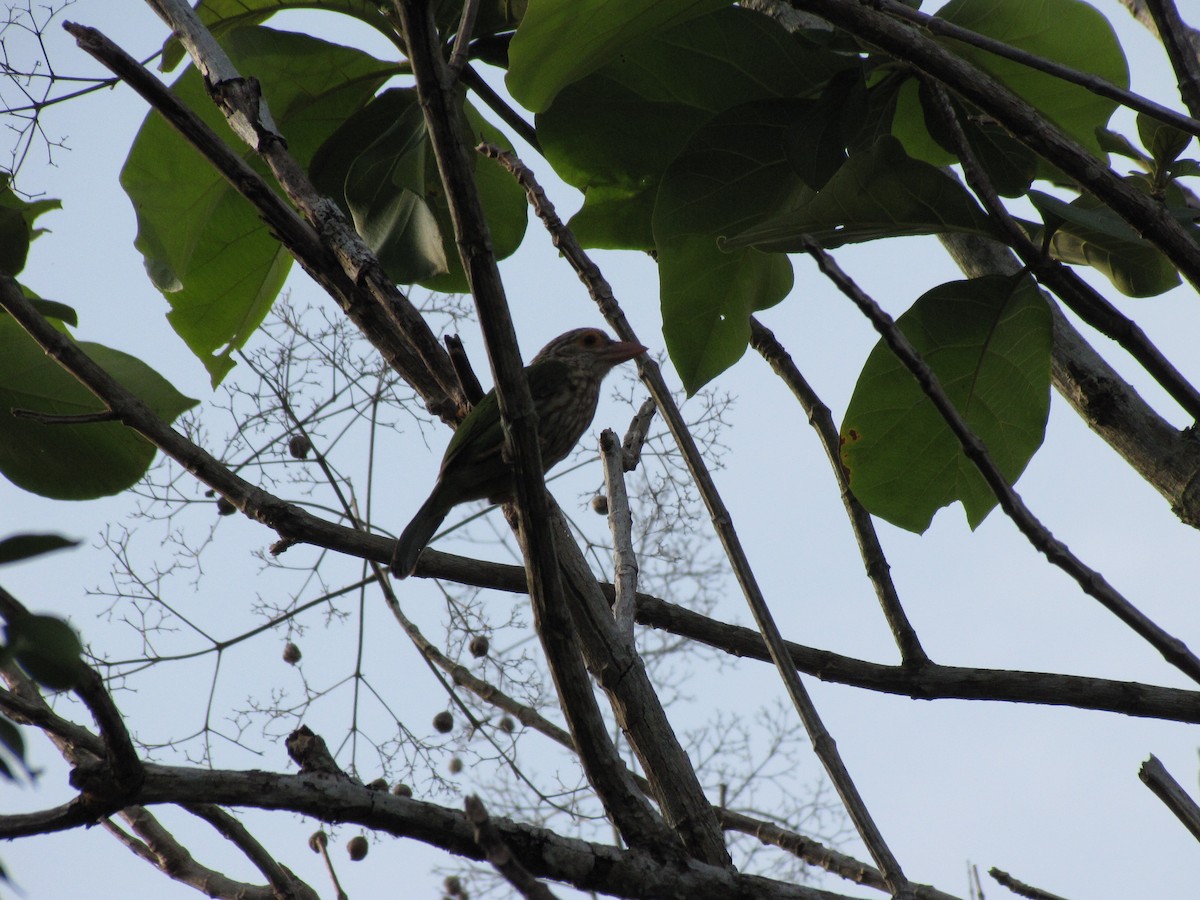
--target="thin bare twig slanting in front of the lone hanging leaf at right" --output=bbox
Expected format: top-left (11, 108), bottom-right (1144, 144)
top-left (804, 238), bottom-right (1200, 682)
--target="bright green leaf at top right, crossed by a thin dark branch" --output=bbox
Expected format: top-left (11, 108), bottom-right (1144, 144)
top-left (937, 0), bottom-right (1129, 154)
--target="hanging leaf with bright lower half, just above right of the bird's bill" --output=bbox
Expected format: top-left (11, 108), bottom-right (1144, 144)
top-left (654, 100), bottom-right (809, 394)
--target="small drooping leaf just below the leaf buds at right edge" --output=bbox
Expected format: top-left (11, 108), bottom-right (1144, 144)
top-left (1028, 191), bottom-right (1180, 296)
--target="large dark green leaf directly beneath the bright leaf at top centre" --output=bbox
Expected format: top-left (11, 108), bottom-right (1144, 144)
top-left (536, 7), bottom-right (857, 250)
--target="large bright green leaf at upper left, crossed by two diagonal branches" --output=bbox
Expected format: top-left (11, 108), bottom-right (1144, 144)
top-left (121, 28), bottom-right (395, 384)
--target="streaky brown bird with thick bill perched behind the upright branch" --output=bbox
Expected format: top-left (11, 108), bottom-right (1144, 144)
top-left (391, 328), bottom-right (646, 578)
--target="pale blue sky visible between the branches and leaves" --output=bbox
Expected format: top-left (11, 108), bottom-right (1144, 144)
top-left (0, 0), bottom-right (1200, 900)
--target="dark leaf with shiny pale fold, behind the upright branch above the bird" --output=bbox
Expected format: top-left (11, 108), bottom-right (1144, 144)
top-left (311, 89), bottom-right (528, 292)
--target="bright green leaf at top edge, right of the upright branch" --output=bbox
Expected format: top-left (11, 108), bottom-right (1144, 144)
top-left (505, 0), bottom-right (730, 113)
